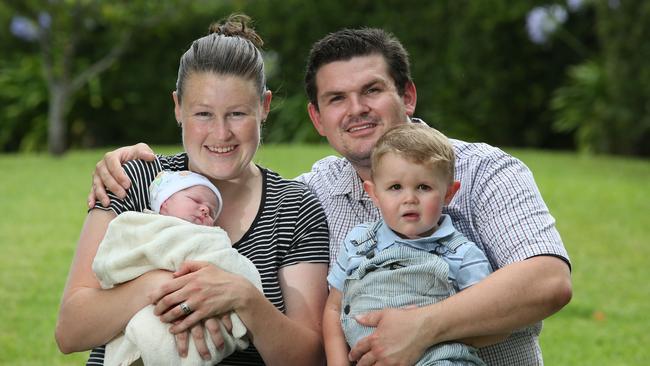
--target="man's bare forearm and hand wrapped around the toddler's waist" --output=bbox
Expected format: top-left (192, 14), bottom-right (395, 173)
top-left (350, 256), bottom-right (571, 366)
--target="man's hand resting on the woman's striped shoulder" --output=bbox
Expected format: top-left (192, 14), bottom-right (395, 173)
top-left (86, 142), bottom-right (156, 208)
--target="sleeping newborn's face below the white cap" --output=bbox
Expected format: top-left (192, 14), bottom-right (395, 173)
top-left (160, 186), bottom-right (218, 226)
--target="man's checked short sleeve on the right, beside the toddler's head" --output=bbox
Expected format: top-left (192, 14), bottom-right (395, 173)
top-left (454, 144), bottom-right (570, 268)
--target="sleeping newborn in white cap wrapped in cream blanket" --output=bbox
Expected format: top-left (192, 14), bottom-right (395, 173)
top-left (93, 171), bottom-right (262, 366)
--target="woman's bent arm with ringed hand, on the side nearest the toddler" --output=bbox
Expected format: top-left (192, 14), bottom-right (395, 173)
top-left (153, 262), bottom-right (327, 365)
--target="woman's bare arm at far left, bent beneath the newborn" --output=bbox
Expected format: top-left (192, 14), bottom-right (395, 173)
top-left (55, 209), bottom-right (171, 353)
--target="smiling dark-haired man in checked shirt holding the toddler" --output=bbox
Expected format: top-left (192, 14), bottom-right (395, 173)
top-left (89, 29), bottom-right (572, 366)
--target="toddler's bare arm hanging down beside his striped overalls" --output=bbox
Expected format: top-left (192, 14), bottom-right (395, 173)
top-left (323, 287), bottom-right (350, 366)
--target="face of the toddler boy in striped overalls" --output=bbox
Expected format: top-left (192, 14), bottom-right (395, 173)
top-left (369, 153), bottom-right (449, 239)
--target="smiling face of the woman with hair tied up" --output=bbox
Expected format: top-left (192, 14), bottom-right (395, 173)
top-left (173, 72), bottom-right (271, 180)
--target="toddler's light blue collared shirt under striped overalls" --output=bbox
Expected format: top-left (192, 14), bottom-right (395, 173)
top-left (327, 215), bottom-right (492, 291)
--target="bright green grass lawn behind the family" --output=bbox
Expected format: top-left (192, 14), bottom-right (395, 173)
top-left (0, 146), bottom-right (650, 365)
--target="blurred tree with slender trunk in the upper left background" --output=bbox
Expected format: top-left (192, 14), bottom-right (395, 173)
top-left (1, 0), bottom-right (230, 155)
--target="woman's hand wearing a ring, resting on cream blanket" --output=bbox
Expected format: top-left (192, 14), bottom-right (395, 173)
top-left (151, 261), bottom-right (254, 334)
